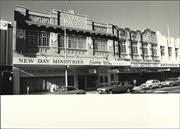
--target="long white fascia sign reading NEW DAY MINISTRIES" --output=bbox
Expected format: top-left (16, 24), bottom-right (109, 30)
top-left (13, 57), bottom-right (130, 66)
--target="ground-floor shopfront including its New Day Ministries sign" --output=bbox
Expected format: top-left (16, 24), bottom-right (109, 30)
top-left (13, 56), bottom-right (130, 94)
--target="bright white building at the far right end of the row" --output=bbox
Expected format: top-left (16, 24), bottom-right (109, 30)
top-left (156, 31), bottom-right (180, 78)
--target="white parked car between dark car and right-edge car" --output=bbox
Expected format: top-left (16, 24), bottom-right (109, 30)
top-left (140, 79), bottom-right (163, 89)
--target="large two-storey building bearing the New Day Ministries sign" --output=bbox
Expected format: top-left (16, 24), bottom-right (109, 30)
top-left (13, 7), bottom-right (130, 94)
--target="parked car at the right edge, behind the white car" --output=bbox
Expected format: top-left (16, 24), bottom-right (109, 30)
top-left (161, 78), bottom-right (180, 86)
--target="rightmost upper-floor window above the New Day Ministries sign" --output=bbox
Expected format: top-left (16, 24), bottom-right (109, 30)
top-left (94, 39), bottom-right (107, 51)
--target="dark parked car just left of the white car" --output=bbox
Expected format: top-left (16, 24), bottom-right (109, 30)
top-left (97, 82), bottom-right (134, 94)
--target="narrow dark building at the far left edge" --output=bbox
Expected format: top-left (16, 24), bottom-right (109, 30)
top-left (0, 20), bottom-right (13, 94)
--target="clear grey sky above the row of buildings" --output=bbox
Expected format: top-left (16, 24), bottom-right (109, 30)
top-left (0, 0), bottom-right (180, 38)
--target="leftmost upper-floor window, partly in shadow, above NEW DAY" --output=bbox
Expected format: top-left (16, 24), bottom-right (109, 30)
top-left (26, 30), bottom-right (49, 47)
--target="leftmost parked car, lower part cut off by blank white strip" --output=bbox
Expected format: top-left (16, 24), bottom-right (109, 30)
top-left (43, 86), bottom-right (86, 95)
